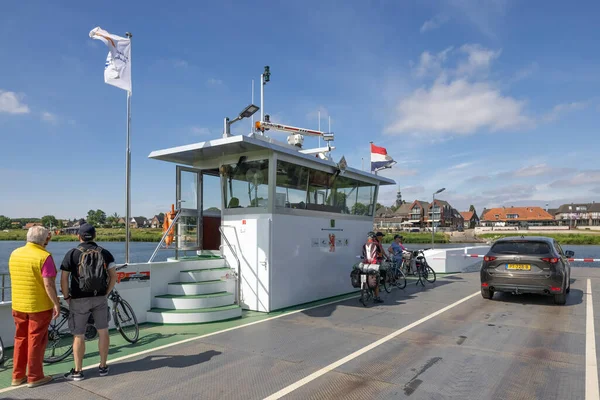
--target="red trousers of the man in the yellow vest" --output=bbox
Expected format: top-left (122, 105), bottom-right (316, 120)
top-left (13, 310), bottom-right (52, 383)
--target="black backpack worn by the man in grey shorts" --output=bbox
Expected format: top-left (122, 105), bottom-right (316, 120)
top-left (77, 246), bottom-right (108, 296)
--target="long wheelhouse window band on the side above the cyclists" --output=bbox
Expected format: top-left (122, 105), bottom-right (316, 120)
top-left (275, 160), bottom-right (375, 216)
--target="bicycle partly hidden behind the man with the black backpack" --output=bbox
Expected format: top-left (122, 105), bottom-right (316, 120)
top-left (44, 264), bottom-right (140, 364)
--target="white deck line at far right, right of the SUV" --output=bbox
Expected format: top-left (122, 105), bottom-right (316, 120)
top-left (585, 279), bottom-right (600, 400)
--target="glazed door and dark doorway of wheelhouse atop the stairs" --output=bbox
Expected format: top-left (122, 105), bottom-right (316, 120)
top-left (176, 166), bottom-right (221, 250)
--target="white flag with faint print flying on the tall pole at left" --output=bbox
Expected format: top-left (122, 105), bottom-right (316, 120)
top-left (90, 26), bottom-right (131, 92)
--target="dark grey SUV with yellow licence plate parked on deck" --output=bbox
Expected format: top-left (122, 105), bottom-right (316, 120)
top-left (481, 236), bottom-right (575, 305)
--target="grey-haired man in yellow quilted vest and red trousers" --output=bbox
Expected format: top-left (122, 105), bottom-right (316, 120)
top-left (8, 226), bottom-right (60, 387)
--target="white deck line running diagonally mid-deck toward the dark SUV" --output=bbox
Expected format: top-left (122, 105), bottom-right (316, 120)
top-left (264, 291), bottom-right (481, 400)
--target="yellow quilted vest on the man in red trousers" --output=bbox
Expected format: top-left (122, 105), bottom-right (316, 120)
top-left (8, 243), bottom-right (53, 313)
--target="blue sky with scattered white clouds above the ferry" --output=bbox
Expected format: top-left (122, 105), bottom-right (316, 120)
top-left (0, 0), bottom-right (600, 218)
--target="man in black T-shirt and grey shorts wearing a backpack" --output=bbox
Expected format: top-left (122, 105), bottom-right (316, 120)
top-left (60, 223), bottom-right (117, 381)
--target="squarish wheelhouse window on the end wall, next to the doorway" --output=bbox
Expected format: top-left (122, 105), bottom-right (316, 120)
top-left (222, 160), bottom-right (269, 208)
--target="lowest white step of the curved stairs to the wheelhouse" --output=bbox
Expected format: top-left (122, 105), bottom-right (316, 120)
top-left (147, 304), bottom-right (242, 324)
